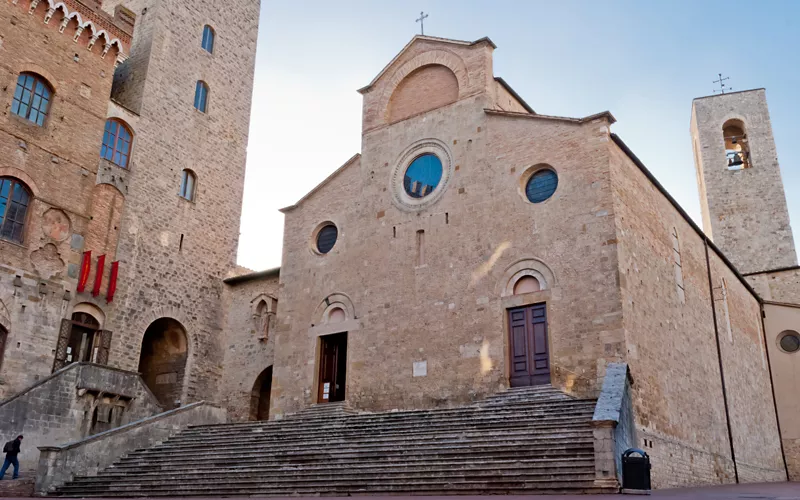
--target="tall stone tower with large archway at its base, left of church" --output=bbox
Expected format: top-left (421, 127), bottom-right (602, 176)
top-left (96, 0), bottom-right (259, 407)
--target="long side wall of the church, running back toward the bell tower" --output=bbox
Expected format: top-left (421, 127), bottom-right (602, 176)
top-left (611, 139), bottom-right (783, 488)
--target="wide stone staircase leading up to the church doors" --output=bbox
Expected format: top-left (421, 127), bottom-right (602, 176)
top-left (54, 386), bottom-right (614, 497)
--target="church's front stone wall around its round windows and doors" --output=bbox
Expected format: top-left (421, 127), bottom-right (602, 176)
top-left (272, 40), bottom-right (625, 415)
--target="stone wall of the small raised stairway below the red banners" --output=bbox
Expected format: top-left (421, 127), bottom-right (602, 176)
top-left (0, 363), bottom-right (161, 470)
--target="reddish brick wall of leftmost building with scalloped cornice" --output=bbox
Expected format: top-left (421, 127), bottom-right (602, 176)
top-left (0, 1), bottom-right (129, 397)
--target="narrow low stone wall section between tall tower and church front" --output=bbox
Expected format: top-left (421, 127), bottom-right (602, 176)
top-left (218, 275), bottom-right (278, 421)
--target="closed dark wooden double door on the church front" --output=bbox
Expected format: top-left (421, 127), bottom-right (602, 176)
top-left (508, 304), bottom-right (550, 387)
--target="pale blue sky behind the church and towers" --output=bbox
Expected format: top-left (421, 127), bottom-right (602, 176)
top-left (239, 0), bottom-right (800, 270)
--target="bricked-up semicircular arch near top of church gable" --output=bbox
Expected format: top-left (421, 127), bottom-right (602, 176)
top-left (389, 65), bottom-right (458, 122)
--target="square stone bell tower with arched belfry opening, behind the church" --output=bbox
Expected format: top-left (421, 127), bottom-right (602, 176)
top-left (691, 89), bottom-right (797, 274)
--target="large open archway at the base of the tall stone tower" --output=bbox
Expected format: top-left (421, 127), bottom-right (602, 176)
top-left (139, 318), bottom-right (188, 409)
